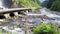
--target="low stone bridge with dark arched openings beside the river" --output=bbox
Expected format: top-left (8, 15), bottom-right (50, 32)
top-left (0, 8), bottom-right (32, 19)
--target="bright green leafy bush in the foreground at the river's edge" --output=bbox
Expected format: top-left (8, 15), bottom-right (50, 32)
top-left (33, 23), bottom-right (58, 34)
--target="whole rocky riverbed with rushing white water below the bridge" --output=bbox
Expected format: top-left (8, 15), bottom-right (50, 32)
top-left (0, 8), bottom-right (60, 34)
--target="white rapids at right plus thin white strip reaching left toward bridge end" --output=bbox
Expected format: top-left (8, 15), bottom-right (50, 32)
top-left (27, 8), bottom-right (60, 19)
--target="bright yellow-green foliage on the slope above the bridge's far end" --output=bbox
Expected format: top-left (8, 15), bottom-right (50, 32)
top-left (16, 0), bottom-right (41, 9)
